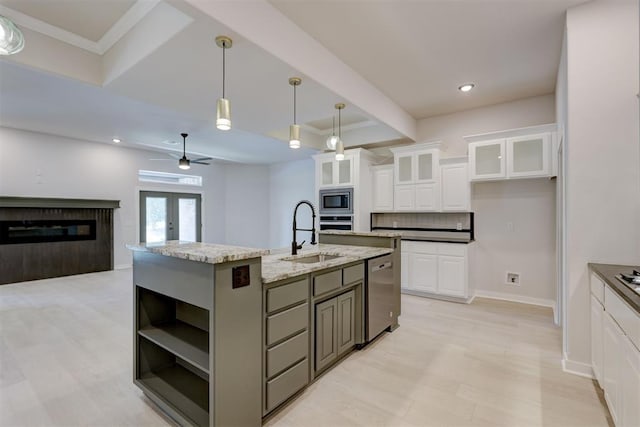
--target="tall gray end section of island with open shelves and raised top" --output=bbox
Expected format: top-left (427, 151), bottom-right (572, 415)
top-left (130, 242), bottom-right (268, 426)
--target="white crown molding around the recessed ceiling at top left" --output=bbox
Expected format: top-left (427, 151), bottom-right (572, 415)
top-left (0, 0), bottom-right (160, 55)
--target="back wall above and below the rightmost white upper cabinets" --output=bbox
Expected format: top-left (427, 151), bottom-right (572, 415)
top-left (418, 95), bottom-right (556, 305)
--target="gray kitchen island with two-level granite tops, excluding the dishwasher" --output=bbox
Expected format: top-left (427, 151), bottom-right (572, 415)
top-left (129, 242), bottom-right (396, 425)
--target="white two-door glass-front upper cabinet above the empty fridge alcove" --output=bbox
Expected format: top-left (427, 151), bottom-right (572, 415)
top-left (465, 125), bottom-right (557, 181)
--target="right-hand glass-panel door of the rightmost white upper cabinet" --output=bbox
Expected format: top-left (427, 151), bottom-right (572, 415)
top-left (506, 133), bottom-right (551, 178)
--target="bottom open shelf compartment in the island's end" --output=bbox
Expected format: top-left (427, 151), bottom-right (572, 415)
top-left (136, 338), bottom-right (209, 425)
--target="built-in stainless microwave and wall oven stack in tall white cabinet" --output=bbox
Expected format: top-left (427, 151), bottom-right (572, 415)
top-left (318, 187), bottom-right (353, 231)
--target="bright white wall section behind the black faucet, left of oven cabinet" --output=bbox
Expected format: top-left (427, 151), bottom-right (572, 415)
top-left (269, 159), bottom-right (318, 248)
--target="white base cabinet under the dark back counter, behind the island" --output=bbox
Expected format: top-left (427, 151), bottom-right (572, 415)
top-left (401, 241), bottom-right (473, 302)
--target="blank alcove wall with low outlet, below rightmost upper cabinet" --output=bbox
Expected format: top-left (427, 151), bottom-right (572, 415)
top-left (471, 179), bottom-right (556, 306)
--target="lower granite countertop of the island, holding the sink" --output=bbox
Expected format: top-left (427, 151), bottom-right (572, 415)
top-left (262, 243), bottom-right (393, 284)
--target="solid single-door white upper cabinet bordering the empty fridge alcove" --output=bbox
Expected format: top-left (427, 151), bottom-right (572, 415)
top-left (440, 159), bottom-right (471, 212)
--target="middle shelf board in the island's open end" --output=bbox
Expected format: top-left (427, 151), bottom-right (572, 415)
top-left (138, 320), bottom-right (209, 374)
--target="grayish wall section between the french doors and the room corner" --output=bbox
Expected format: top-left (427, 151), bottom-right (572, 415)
top-left (223, 163), bottom-right (271, 248)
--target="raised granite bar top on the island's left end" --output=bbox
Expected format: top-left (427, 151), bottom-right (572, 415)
top-left (127, 240), bottom-right (269, 264)
